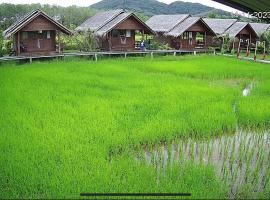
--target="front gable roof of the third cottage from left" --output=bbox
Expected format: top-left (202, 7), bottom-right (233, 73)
top-left (165, 17), bottom-right (215, 37)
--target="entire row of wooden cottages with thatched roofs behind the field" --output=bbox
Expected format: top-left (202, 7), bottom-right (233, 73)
top-left (3, 9), bottom-right (270, 55)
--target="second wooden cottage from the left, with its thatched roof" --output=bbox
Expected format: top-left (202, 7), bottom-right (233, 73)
top-left (76, 9), bottom-right (155, 51)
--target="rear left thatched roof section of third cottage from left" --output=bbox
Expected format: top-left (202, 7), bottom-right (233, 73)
top-left (146, 14), bottom-right (190, 33)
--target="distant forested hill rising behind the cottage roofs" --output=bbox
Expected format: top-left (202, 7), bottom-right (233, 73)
top-left (90, 0), bottom-right (232, 17)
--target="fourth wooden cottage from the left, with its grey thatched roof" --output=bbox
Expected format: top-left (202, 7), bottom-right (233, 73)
top-left (203, 19), bottom-right (258, 49)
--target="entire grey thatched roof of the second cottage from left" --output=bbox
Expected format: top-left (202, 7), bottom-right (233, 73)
top-left (76, 10), bottom-right (155, 37)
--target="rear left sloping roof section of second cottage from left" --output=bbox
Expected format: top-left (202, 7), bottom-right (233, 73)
top-left (75, 9), bottom-right (124, 31)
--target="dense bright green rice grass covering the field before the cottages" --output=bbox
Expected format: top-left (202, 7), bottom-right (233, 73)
top-left (0, 56), bottom-right (270, 198)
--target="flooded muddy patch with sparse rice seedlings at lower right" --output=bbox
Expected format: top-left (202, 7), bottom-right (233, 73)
top-left (138, 131), bottom-right (270, 198)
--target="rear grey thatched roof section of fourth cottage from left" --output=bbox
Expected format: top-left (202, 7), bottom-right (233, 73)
top-left (203, 18), bottom-right (237, 35)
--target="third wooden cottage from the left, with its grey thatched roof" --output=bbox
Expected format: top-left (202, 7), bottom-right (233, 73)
top-left (146, 15), bottom-right (215, 50)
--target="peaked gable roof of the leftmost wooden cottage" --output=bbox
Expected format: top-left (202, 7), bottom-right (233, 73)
top-left (3, 10), bottom-right (72, 38)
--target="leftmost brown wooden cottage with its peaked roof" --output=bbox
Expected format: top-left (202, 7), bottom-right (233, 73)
top-left (3, 10), bottom-right (72, 55)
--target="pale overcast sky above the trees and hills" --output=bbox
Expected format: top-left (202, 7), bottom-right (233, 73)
top-left (0, 0), bottom-right (240, 12)
